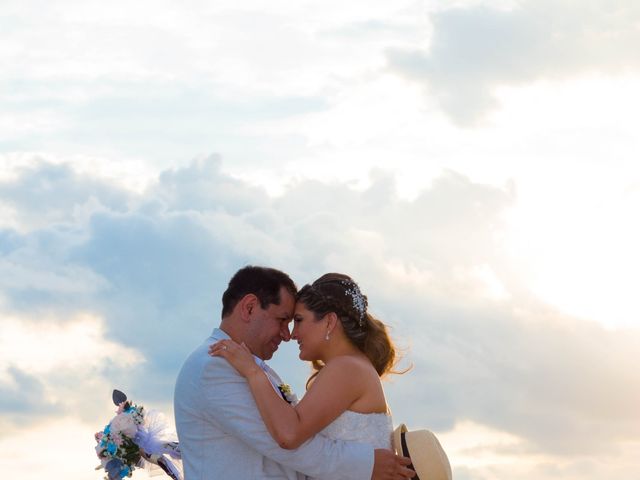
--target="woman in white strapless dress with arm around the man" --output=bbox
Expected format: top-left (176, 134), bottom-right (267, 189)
top-left (210, 273), bottom-right (395, 449)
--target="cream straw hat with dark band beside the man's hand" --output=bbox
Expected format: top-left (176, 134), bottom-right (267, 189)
top-left (393, 423), bottom-right (452, 480)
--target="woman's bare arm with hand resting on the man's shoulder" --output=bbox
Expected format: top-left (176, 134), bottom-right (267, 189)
top-left (210, 340), bottom-right (365, 449)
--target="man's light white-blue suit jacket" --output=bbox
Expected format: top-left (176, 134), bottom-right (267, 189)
top-left (174, 329), bottom-right (373, 480)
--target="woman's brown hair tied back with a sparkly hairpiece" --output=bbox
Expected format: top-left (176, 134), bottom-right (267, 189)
top-left (296, 273), bottom-right (396, 386)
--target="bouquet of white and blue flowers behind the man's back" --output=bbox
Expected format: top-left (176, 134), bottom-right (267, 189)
top-left (95, 390), bottom-right (182, 480)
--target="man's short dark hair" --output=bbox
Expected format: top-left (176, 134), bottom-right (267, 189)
top-left (222, 265), bottom-right (298, 318)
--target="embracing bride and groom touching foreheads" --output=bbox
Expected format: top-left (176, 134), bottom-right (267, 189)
top-left (174, 266), bottom-right (415, 480)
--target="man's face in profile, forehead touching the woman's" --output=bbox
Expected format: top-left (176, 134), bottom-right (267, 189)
top-left (246, 288), bottom-right (295, 360)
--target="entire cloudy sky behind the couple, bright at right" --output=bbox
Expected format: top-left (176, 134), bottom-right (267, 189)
top-left (0, 0), bottom-right (640, 480)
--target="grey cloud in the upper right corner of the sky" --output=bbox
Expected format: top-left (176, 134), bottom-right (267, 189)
top-left (388, 0), bottom-right (640, 125)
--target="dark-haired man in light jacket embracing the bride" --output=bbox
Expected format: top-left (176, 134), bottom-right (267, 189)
top-left (174, 266), bottom-right (414, 480)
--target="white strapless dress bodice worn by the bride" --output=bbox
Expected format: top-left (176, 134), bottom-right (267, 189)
top-left (312, 410), bottom-right (393, 480)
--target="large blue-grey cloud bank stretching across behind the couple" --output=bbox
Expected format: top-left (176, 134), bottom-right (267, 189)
top-left (0, 156), bottom-right (640, 468)
